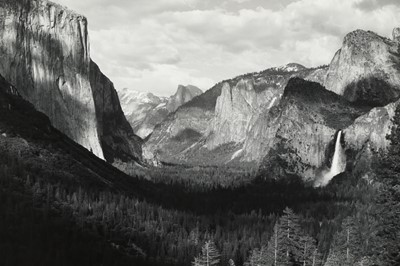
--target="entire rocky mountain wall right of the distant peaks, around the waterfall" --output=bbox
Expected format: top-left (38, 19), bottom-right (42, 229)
top-left (144, 29), bottom-right (400, 182)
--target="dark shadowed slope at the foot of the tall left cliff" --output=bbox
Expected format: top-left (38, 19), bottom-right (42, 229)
top-left (0, 72), bottom-right (148, 195)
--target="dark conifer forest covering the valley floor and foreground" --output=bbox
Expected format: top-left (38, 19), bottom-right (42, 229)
top-left (0, 104), bottom-right (400, 266)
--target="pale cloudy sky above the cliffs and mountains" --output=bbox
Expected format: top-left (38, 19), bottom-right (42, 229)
top-left (53, 0), bottom-right (400, 96)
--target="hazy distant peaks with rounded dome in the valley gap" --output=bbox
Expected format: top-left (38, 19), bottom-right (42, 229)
top-left (119, 85), bottom-right (202, 139)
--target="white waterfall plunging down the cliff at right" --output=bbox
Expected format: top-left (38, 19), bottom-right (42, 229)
top-left (315, 131), bottom-right (346, 187)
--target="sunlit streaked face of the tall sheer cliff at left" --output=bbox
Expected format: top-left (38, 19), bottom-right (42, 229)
top-left (0, 0), bottom-right (103, 157)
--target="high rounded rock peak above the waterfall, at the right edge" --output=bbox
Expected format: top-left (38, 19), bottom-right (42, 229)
top-left (325, 30), bottom-right (400, 106)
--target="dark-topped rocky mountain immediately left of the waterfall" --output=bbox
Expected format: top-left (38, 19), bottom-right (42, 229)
top-left (247, 78), bottom-right (365, 179)
